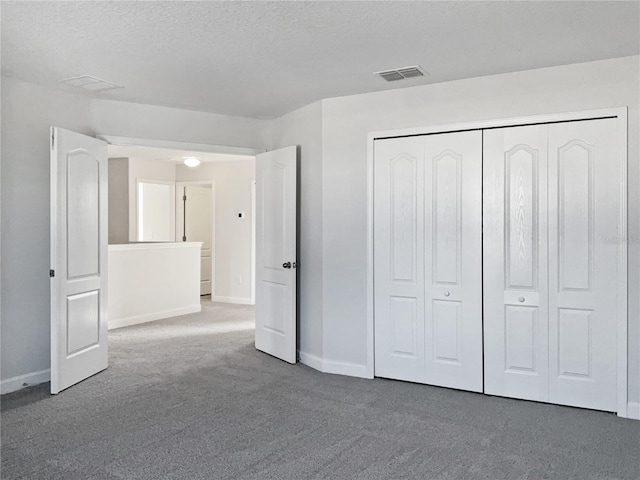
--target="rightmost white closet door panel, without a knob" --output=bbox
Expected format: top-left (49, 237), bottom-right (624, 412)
top-left (549, 119), bottom-right (621, 411)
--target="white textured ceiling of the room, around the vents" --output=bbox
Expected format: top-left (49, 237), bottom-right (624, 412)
top-left (1, 1), bottom-right (640, 118)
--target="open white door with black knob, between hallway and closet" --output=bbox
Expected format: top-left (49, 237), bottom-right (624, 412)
top-left (256, 147), bottom-right (297, 363)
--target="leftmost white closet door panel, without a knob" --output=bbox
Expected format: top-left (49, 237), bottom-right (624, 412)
top-left (374, 137), bottom-right (425, 382)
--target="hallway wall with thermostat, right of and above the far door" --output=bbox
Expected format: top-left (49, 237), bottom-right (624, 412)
top-left (176, 160), bottom-right (256, 303)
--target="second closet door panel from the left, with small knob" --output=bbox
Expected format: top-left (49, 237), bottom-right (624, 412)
top-left (424, 131), bottom-right (482, 392)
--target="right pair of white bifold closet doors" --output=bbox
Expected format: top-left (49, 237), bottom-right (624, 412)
top-left (483, 119), bottom-right (622, 411)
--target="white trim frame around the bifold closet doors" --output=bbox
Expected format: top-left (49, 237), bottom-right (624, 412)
top-left (366, 107), bottom-right (628, 418)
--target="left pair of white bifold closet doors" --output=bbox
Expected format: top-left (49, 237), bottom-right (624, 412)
top-left (374, 131), bottom-right (482, 391)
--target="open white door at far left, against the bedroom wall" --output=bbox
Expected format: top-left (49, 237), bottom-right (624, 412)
top-left (49, 127), bottom-right (108, 394)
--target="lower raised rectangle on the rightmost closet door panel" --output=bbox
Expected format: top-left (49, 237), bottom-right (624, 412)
top-left (557, 308), bottom-right (593, 379)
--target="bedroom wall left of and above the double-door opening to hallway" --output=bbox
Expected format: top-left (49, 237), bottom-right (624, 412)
top-left (0, 76), bottom-right (268, 386)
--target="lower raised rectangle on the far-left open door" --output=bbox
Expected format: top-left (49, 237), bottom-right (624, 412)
top-left (67, 290), bottom-right (100, 357)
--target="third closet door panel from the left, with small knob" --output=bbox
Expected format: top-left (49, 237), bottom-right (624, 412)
top-left (483, 125), bottom-right (548, 401)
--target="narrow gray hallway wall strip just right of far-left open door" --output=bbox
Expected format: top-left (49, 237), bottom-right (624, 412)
top-left (109, 158), bottom-right (129, 244)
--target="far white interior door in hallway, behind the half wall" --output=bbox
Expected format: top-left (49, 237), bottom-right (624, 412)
top-left (183, 185), bottom-right (213, 295)
